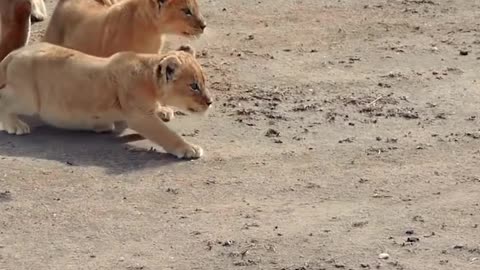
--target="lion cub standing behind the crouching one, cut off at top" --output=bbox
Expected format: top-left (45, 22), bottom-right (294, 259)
top-left (44, 0), bottom-right (205, 57)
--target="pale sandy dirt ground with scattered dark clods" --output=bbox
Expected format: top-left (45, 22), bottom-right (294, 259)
top-left (0, 0), bottom-right (480, 270)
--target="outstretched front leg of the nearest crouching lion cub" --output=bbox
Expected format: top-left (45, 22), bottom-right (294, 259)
top-left (127, 115), bottom-right (203, 159)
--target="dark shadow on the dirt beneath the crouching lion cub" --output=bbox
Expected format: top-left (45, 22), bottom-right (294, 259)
top-left (0, 121), bottom-right (181, 174)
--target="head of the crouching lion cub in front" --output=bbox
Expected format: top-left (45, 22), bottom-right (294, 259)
top-left (155, 46), bottom-right (213, 113)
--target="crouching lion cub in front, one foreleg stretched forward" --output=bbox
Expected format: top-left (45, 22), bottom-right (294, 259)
top-left (0, 43), bottom-right (212, 158)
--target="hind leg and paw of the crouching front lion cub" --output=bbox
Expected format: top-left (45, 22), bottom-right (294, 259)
top-left (0, 85), bottom-right (30, 135)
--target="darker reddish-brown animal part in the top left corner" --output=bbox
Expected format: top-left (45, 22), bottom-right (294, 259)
top-left (0, 0), bottom-right (32, 61)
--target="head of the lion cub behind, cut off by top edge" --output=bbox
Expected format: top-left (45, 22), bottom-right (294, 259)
top-left (154, 0), bottom-right (207, 36)
